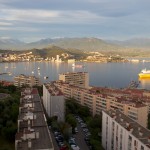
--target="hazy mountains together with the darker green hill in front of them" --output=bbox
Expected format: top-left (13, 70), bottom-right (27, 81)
top-left (0, 38), bottom-right (150, 57)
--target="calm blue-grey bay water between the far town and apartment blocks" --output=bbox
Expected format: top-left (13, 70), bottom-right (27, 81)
top-left (0, 62), bottom-right (150, 89)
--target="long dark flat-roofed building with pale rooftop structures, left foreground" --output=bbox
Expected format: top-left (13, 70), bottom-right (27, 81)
top-left (15, 88), bottom-right (54, 150)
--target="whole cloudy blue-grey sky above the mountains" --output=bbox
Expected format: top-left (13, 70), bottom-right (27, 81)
top-left (0, 0), bottom-right (150, 42)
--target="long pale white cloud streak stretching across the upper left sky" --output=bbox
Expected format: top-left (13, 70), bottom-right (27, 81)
top-left (0, 9), bottom-right (100, 24)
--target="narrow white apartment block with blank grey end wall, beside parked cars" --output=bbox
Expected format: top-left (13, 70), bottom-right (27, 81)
top-left (43, 83), bottom-right (65, 121)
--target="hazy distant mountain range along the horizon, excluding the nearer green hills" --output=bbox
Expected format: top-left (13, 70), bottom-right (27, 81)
top-left (0, 38), bottom-right (150, 51)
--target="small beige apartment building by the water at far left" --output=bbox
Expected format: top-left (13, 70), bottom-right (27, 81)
top-left (14, 74), bottom-right (41, 87)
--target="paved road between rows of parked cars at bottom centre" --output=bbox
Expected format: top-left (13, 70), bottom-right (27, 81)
top-left (74, 124), bottom-right (89, 150)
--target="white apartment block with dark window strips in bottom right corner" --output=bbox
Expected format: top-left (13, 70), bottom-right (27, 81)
top-left (102, 110), bottom-right (150, 150)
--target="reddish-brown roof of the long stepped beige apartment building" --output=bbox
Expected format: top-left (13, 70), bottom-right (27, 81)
top-left (53, 80), bottom-right (146, 108)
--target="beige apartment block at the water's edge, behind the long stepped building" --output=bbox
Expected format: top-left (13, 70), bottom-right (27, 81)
top-left (59, 72), bottom-right (89, 88)
